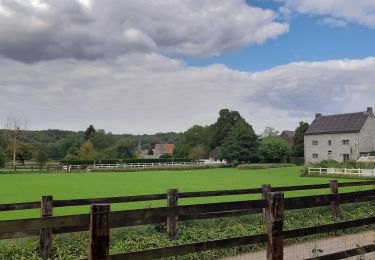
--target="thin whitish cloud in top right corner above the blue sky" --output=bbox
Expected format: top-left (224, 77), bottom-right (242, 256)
top-left (277, 0), bottom-right (375, 28)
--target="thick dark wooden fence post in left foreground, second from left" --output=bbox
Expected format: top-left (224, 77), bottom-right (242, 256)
top-left (88, 204), bottom-right (110, 260)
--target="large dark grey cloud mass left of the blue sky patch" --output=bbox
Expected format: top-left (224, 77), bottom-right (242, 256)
top-left (0, 0), bottom-right (289, 62)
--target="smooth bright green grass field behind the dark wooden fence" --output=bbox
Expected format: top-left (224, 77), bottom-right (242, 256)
top-left (0, 167), bottom-right (372, 220)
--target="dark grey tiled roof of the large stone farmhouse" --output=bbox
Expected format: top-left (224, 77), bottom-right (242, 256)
top-left (305, 112), bottom-right (368, 135)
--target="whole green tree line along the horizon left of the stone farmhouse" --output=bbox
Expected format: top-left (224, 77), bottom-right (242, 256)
top-left (0, 109), bottom-right (309, 166)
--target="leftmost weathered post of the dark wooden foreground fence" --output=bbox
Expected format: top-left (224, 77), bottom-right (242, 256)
top-left (39, 196), bottom-right (53, 259)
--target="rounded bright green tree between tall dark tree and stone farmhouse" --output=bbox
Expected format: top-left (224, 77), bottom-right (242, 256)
top-left (258, 137), bottom-right (291, 162)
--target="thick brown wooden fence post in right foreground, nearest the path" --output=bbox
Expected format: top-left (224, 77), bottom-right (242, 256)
top-left (266, 192), bottom-right (284, 260)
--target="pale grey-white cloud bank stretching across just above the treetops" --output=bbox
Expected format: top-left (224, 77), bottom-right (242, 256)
top-left (0, 53), bottom-right (375, 133)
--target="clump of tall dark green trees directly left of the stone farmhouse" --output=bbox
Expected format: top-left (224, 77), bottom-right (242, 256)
top-left (174, 109), bottom-right (309, 163)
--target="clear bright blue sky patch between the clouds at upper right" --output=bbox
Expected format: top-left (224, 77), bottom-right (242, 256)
top-left (188, 0), bottom-right (375, 72)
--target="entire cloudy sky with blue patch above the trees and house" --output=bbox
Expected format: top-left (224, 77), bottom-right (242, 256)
top-left (0, 0), bottom-right (375, 134)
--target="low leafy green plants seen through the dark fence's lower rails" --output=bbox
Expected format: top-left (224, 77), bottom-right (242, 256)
top-left (0, 202), bottom-right (375, 259)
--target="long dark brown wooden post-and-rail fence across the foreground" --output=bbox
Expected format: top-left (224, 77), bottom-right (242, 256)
top-left (0, 180), bottom-right (375, 259)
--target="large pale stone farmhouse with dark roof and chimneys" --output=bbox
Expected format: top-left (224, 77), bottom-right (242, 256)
top-left (304, 107), bottom-right (375, 163)
